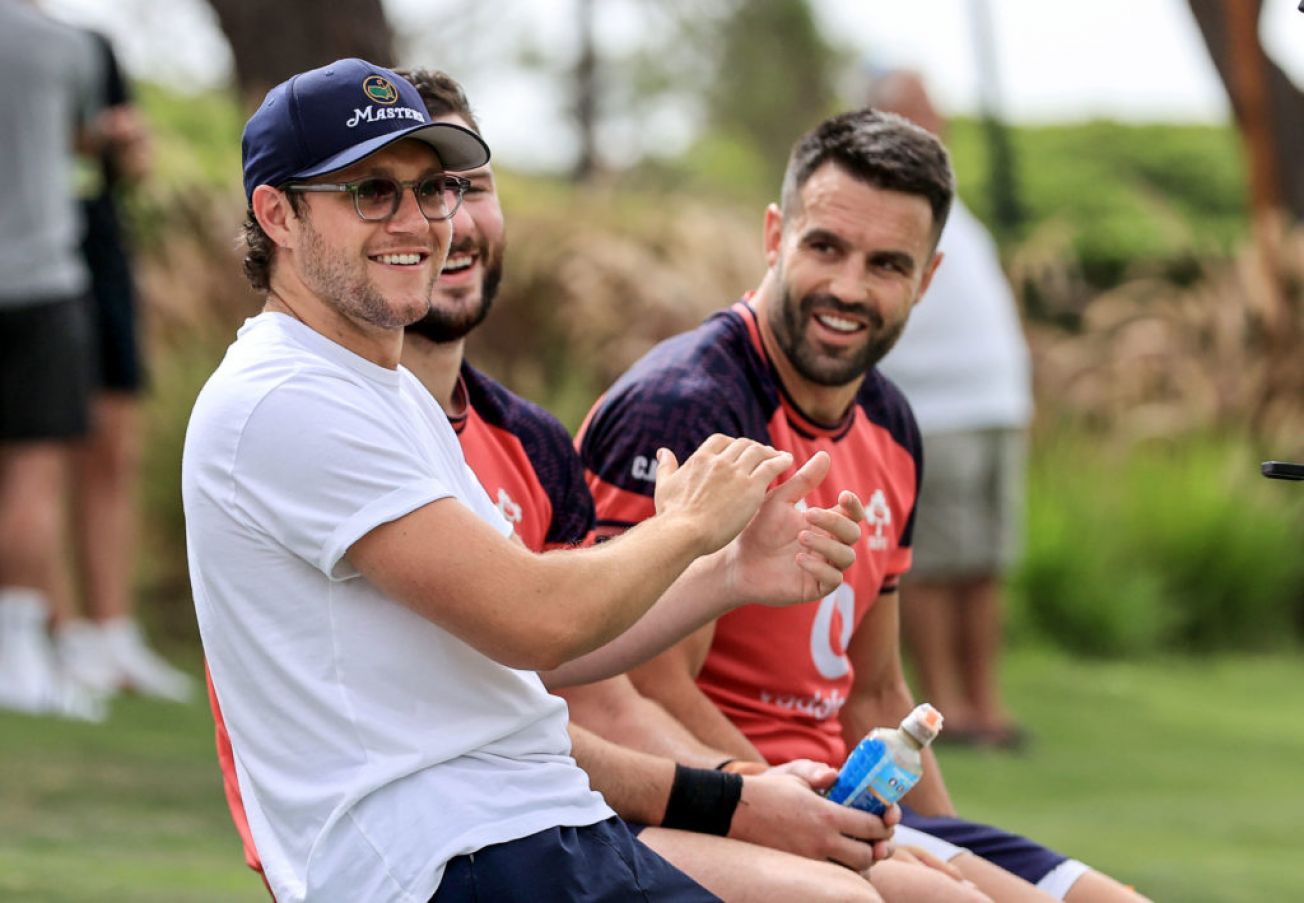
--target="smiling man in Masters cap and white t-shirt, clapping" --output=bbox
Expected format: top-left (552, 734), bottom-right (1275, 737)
top-left (183, 60), bottom-right (887, 903)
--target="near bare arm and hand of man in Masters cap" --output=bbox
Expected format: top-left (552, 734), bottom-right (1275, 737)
top-left (348, 436), bottom-right (792, 671)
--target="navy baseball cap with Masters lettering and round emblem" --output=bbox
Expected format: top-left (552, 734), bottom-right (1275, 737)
top-left (240, 59), bottom-right (489, 201)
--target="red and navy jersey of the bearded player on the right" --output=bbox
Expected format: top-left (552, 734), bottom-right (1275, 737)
top-left (579, 301), bottom-right (922, 763)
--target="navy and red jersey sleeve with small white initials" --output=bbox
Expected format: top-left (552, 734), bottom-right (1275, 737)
top-left (578, 382), bottom-right (742, 540)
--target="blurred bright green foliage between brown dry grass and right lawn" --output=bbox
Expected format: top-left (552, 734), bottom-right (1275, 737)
top-left (1012, 435), bottom-right (1304, 655)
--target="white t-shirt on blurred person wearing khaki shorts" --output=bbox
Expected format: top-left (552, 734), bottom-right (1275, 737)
top-left (879, 198), bottom-right (1033, 436)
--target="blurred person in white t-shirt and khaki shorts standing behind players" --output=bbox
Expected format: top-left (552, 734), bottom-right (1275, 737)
top-left (868, 70), bottom-right (1033, 749)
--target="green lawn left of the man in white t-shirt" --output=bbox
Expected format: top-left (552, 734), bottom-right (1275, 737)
top-left (0, 652), bottom-right (267, 903)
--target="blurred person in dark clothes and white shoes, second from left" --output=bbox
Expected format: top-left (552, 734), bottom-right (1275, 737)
top-left (55, 26), bottom-right (190, 702)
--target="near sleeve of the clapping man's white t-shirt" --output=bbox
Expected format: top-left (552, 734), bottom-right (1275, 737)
top-left (231, 378), bottom-right (456, 579)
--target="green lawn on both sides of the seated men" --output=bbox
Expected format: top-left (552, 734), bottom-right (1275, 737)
top-left (0, 650), bottom-right (1304, 903)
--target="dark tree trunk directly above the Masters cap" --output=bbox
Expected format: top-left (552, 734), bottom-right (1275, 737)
top-left (209, 0), bottom-right (394, 107)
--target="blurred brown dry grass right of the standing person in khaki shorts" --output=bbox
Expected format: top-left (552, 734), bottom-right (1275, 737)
top-left (1011, 219), bottom-right (1304, 458)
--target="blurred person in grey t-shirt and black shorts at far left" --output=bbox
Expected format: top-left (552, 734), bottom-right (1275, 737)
top-left (0, 0), bottom-right (104, 719)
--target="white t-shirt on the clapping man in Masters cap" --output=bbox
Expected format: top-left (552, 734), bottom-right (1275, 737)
top-left (181, 313), bottom-right (612, 903)
